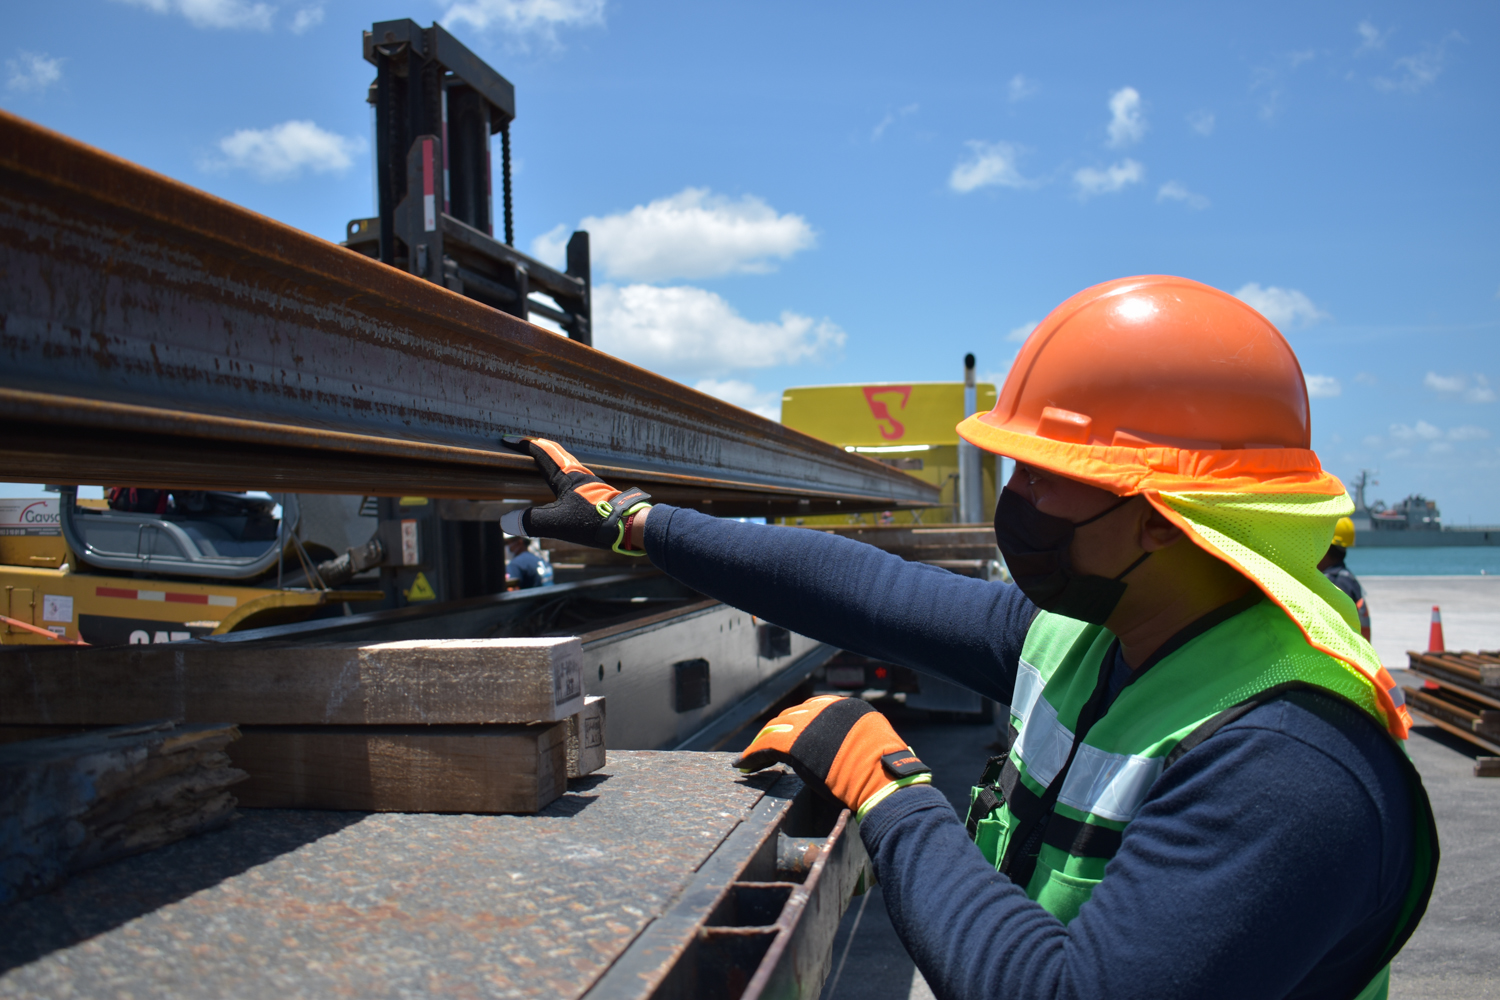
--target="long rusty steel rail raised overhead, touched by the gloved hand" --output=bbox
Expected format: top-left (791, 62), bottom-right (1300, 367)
top-left (0, 112), bottom-right (938, 516)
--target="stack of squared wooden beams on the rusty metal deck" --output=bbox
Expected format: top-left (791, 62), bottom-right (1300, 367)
top-left (0, 637), bottom-right (603, 813)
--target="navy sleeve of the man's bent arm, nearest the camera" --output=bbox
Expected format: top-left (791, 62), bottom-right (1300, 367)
top-left (860, 689), bottom-right (1412, 1000)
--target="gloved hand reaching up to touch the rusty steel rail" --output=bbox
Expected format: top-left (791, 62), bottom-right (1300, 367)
top-left (500, 438), bottom-right (651, 556)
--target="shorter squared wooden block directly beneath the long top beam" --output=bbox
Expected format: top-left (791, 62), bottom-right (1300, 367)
top-left (230, 720), bottom-right (567, 813)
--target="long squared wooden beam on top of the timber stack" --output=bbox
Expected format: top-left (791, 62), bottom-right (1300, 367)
top-left (0, 637), bottom-right (584, 726)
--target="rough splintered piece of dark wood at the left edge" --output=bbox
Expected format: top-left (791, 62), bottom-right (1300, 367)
top-left (0, 721), bottom-right (246, 906)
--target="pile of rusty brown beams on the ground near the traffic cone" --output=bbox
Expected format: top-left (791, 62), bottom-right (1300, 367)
top-left (1406, 649), bottom-right (1500, 777)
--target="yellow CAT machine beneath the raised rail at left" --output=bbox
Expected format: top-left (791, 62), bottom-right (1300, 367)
top-left (0, 486), bottom-right (384, 645)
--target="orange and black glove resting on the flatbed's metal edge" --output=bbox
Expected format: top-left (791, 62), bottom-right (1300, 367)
top-left (735, 694), bottom-right (933, 820)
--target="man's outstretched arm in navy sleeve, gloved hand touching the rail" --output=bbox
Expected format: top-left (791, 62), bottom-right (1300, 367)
top-left (503, 438), bottom-right (1037, 703)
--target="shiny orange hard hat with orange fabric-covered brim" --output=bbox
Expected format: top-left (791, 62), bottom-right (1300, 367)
top-left (959, 274), bottom-right (1343, 495)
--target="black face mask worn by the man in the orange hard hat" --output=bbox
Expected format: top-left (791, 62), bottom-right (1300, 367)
top-left (995, 489), bottom-right (1151, 625)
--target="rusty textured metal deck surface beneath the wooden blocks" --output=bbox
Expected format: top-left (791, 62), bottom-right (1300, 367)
top-left (0, 753), bottom-right (782, 1000)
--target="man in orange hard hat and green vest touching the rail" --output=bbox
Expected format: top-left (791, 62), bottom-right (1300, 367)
top-left (507, 276), bottom-right (1437, 1000)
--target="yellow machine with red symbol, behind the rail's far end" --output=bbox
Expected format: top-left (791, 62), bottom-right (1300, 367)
top-left (782, 382), bottom-right (996, 525)
